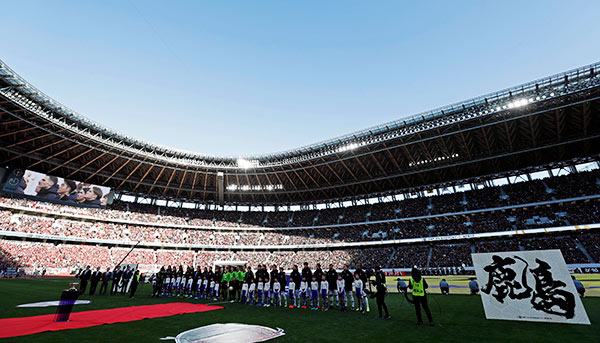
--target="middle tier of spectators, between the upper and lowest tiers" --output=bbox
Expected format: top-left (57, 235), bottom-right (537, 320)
top-left (0, 199), bottom-right (600, 247)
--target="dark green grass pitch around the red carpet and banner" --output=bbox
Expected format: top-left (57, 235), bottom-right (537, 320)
top-left (0, 279), bottom-right (600, 343)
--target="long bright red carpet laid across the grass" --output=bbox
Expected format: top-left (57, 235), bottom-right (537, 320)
top-left (0, 303), bottom-right (223, 338)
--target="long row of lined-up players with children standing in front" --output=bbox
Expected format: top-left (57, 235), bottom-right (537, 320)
top-left (152, 262), bottom-right (370, 313)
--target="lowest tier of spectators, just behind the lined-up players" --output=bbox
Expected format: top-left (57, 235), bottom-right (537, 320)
top-left (0, 233), bottom-right (600, 273)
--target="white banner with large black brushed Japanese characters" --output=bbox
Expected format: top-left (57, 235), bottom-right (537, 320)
top-left (472, 250), bottom-right (590, 324)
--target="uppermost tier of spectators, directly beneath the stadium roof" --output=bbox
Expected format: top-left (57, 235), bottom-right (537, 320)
top-left (0, 170), bottom-right (600, 228)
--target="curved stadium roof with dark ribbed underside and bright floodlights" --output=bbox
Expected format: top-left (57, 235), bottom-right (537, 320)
top-left (0, 61), bottom-right (600, 205)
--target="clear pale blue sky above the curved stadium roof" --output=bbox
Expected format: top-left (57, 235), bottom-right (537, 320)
top-left (0, 0), bottom-right (600, 155)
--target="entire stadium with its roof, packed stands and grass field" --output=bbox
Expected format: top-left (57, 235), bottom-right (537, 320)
top-left (0, 3), bottom-right (600, 342)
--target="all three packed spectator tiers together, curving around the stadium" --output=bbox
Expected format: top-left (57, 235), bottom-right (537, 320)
top-left (0, 170), bottom-right (600, 273)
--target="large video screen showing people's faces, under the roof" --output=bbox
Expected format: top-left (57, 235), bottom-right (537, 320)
top-left (4, 169), bottom-right (110, 207)
